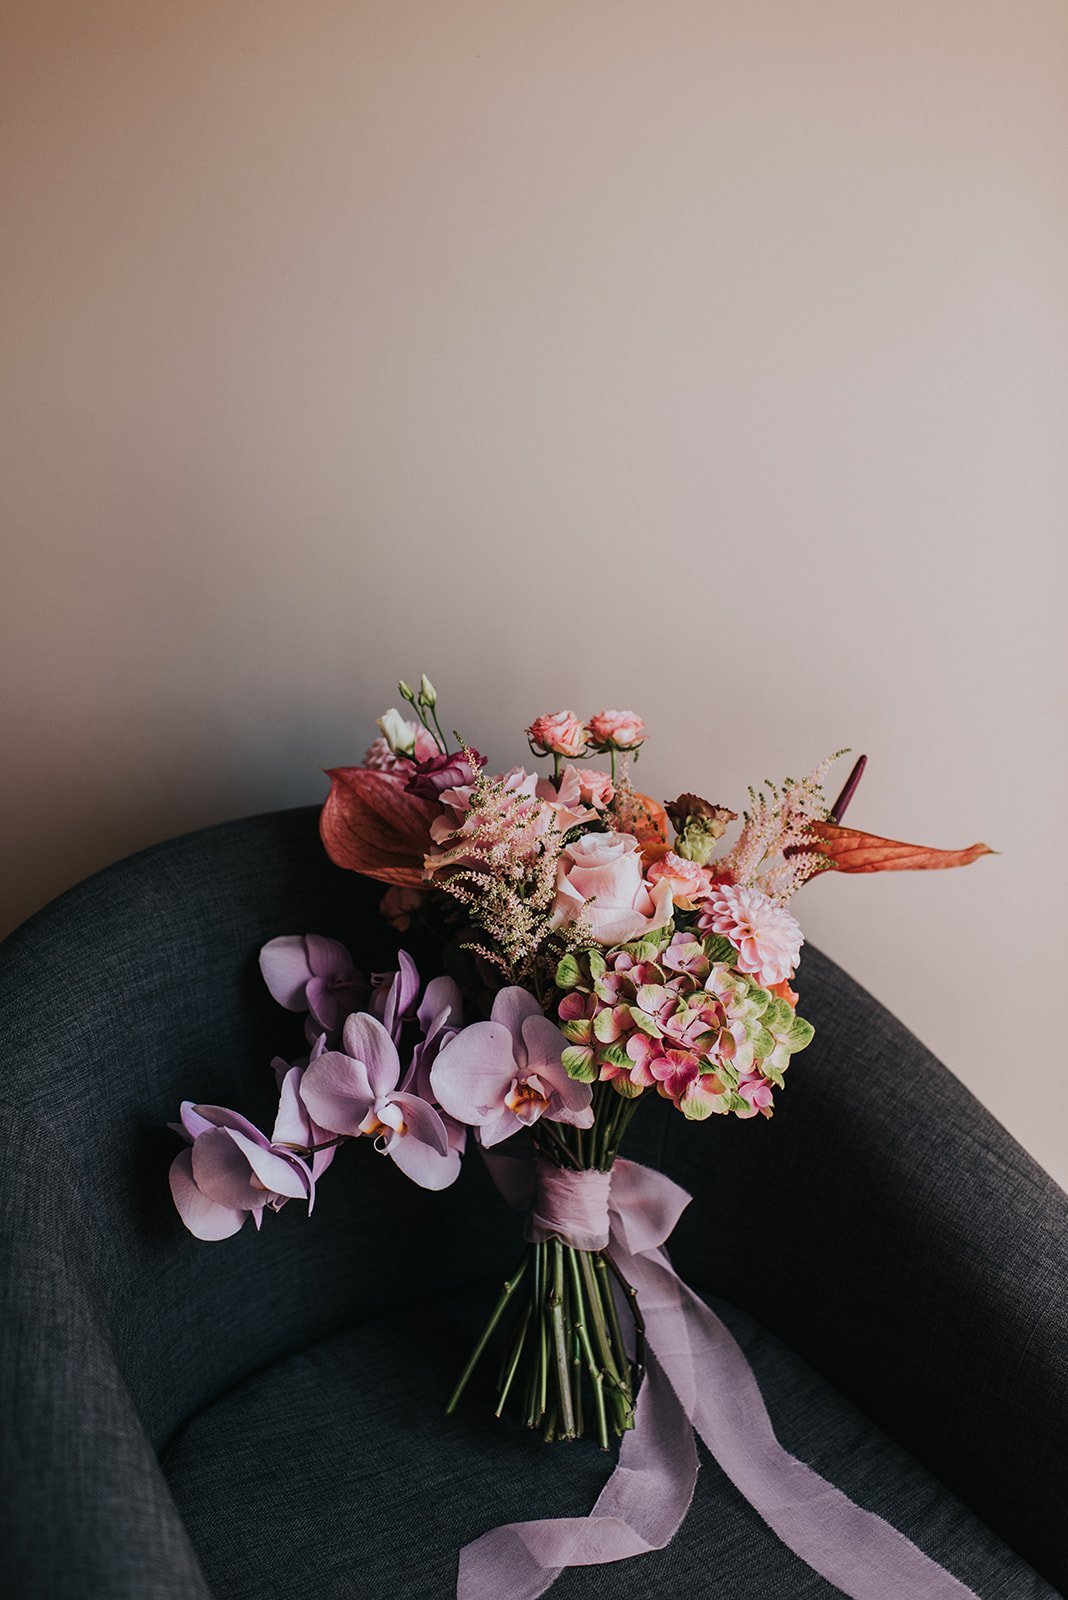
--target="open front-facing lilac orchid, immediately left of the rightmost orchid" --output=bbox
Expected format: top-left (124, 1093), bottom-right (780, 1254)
top-left (301, 1011), bottom-right (460, 1189)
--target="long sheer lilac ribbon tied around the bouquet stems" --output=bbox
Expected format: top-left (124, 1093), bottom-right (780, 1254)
top-left (456, 1154), bottom-right (977, 1600)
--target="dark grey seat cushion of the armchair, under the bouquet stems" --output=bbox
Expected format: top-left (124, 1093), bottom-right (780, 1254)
top-left (163, 1290), bottom-right (1055, 1600)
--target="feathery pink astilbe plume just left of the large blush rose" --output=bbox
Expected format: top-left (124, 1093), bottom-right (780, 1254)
top-left (427, 755), bottom-right (590, 984)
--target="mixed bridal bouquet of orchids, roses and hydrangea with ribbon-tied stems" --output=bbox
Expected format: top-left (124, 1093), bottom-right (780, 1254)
top-left (171, 677), bottom-right (986, 1595)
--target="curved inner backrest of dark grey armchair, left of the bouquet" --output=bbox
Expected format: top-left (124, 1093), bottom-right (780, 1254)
top-left (0, 808), bottom-right (515, 1446)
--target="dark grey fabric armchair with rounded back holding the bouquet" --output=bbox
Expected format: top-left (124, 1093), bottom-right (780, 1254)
top-left (0, 810), bottom-right (1068, 1600)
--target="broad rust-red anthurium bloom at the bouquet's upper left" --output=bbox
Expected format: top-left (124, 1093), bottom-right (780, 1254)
top-left (318, 766), bottom-right (441, 888)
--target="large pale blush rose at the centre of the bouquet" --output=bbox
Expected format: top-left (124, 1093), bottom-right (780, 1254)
top-left (552, 834), bottom-right (673, 944)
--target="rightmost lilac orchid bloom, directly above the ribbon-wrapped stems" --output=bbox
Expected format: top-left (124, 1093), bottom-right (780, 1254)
top-left (430, 987), bottom-right (593, 1146)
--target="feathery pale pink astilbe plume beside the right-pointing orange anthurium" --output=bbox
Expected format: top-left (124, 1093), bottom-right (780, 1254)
top-left (715, 750), bottom-right (846, 906)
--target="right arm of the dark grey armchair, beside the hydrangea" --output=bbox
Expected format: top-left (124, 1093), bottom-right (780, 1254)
top-left (652, 952), bottom-right (1068, 1589)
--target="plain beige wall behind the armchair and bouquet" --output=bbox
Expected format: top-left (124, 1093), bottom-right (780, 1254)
top-left (0, 0), bottom-right (1068, 1182)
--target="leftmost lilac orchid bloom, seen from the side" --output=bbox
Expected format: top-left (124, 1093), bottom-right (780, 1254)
top-left (169, 1101), bottom-right (315, 1238)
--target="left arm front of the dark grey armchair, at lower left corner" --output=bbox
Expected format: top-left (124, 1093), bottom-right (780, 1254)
top-left (0, 1106), bottom-right (211, 1600)
